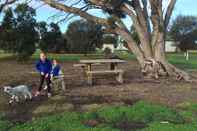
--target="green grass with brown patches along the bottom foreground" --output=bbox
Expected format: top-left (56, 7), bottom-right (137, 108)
top-left (0, 101), bottom-right (197, 131)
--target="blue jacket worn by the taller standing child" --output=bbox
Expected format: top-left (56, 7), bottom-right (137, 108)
top-left (36, 59), bottom-right (52, 74)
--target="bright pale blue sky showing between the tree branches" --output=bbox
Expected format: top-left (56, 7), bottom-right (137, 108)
top-left (2, 0), bottom-right (197, 32)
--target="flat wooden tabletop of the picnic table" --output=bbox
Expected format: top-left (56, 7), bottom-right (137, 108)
top-left (79, 59), bottom-right (126, 64)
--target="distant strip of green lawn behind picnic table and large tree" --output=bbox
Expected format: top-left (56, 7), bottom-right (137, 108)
top-left (0, 51), bottom-right (197, 70)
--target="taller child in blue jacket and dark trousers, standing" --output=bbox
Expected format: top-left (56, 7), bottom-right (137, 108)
top-left (35, 53), bottom-right (52, 97)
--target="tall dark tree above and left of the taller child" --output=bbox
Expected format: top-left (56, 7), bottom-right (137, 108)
top-left (14, 4), bottom-right (38, 60)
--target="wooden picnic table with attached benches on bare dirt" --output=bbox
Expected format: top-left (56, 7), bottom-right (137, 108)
top-left (74, 59), bottom-right (126, 85)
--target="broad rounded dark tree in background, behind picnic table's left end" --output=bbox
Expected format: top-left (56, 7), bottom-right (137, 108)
top-left (65, 20), bottom-right (102, 54)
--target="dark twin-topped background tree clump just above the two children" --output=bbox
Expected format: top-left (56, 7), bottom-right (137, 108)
top-left (38, 22), bottom-right (67, 53)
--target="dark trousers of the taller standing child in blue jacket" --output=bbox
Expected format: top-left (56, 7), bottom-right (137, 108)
top-left (38, 75), bottom-right (51, 93)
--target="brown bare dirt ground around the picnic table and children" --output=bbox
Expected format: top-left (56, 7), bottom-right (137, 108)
top-left (0, 60), bottom-right (197, 122)
